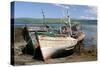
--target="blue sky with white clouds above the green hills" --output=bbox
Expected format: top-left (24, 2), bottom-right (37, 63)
top-left (14, 1), bottom-right (97, 19)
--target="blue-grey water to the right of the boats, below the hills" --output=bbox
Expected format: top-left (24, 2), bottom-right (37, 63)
top-left (82, 25), bottom-right (97, 45)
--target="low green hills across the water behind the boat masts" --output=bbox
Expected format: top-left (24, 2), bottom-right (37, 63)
top-left (14, 18), bottom-right (97, 24)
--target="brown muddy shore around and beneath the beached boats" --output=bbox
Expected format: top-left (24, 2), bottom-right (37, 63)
top-left (12, 28), bottom-right (97, 65)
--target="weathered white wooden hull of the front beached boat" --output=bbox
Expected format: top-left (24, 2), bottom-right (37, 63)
top-left (38, 35), bottom-right (77, 59)
